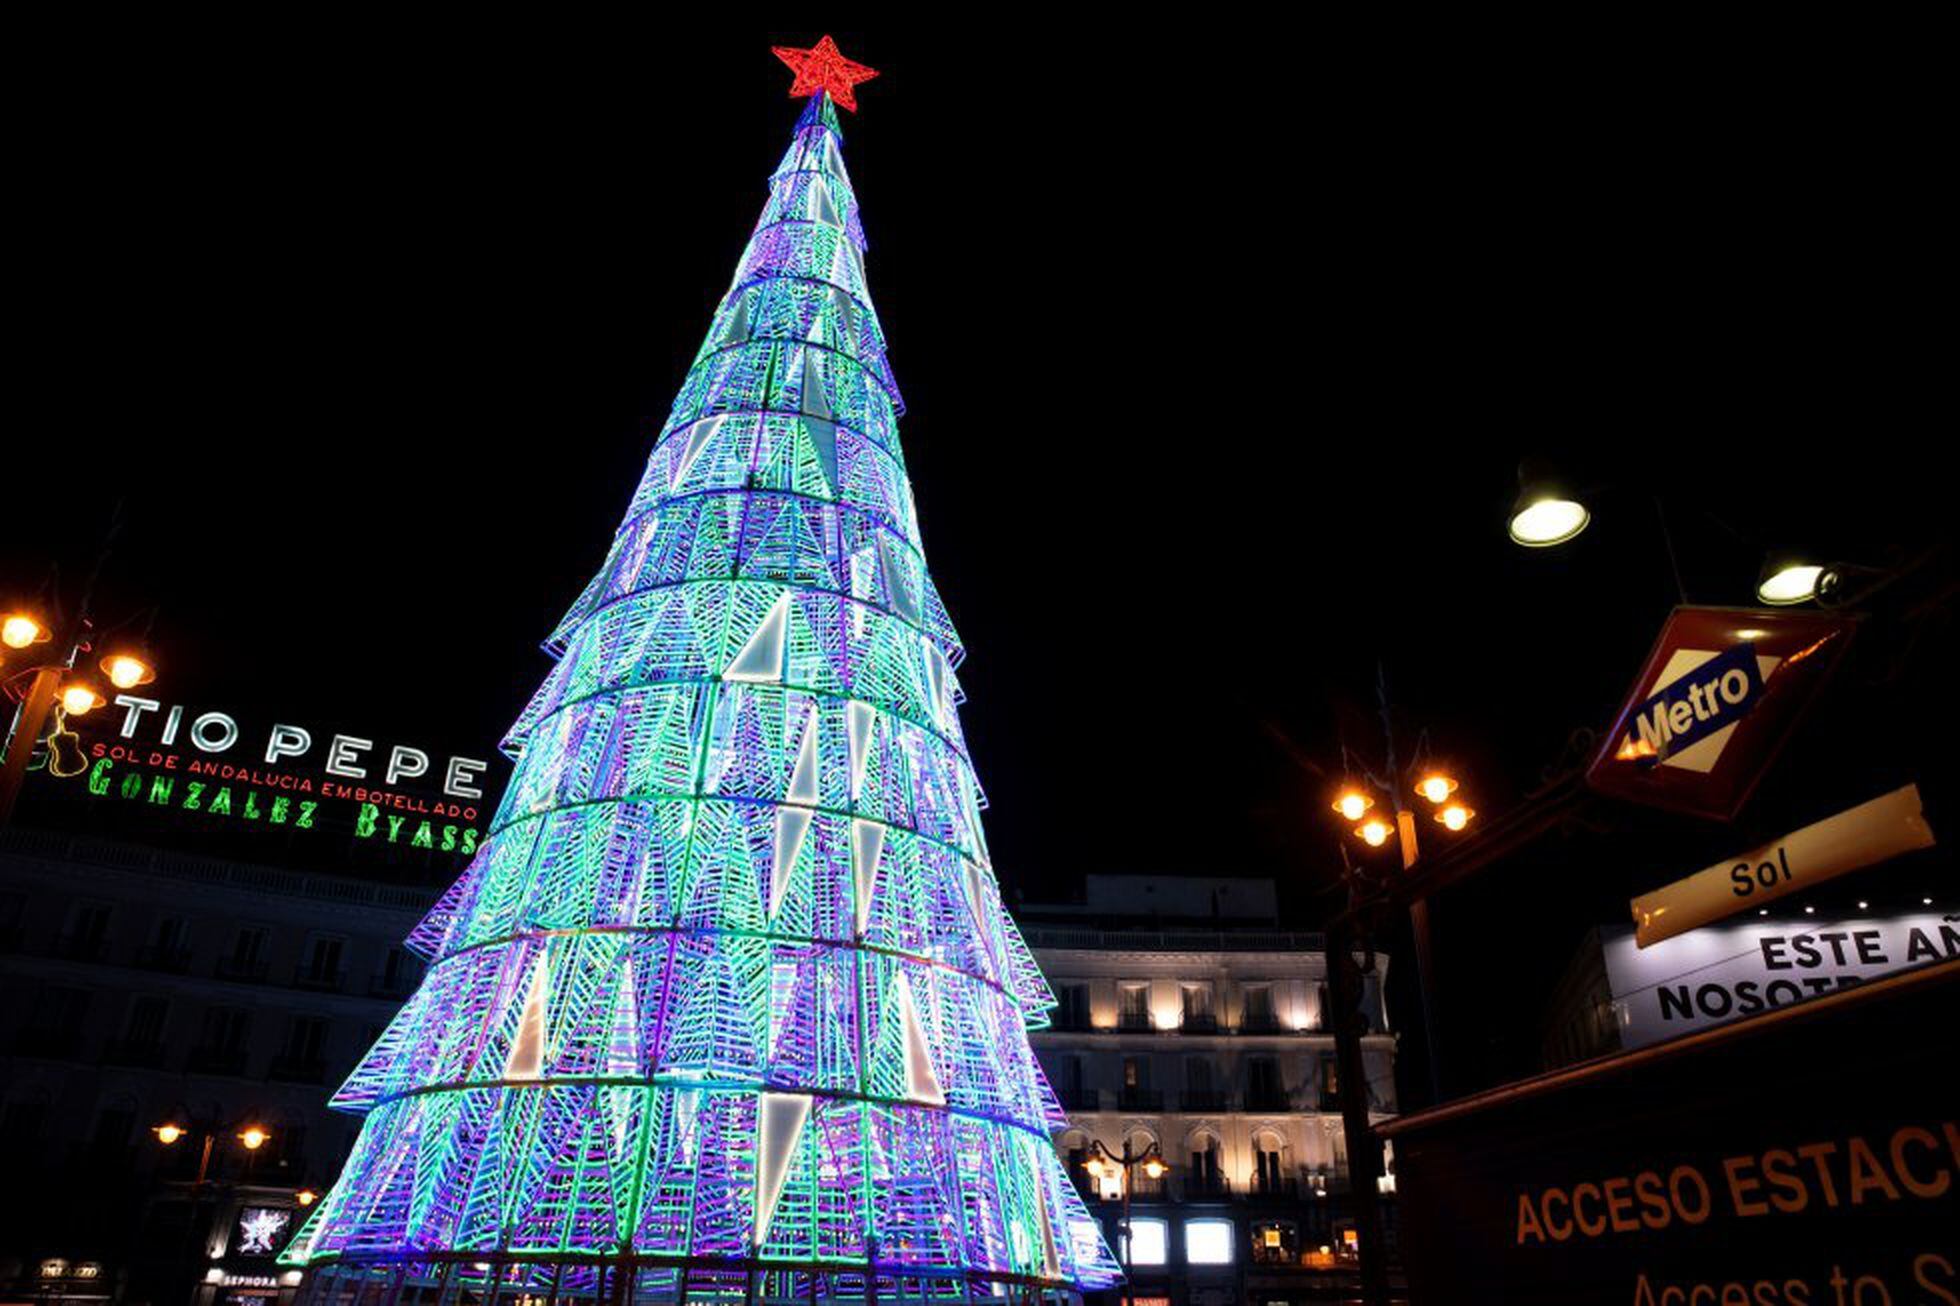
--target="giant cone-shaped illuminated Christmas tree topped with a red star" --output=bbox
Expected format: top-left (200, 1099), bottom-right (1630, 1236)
top-left (284, 37), bottom-right (1117, 1302)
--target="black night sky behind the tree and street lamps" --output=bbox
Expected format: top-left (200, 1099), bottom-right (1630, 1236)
top-left (0, 25), bottom-right (1952, 898)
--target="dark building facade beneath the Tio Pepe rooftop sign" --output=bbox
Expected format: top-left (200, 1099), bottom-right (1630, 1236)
top-left (0, 828), bottom-right (433, 1306)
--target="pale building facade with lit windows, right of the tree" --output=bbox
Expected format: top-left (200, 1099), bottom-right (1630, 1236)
top-left (1015, 877), bottom-right (1396, 1306)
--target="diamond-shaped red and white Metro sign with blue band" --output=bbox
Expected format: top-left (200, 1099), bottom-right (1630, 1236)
top-left (1586, 608), bottom-right (1854, 822)
